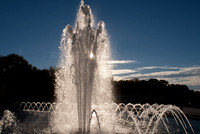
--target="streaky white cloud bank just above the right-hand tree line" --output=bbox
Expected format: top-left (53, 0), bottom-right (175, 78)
top-left (114, 66), bottom-right (200, 90)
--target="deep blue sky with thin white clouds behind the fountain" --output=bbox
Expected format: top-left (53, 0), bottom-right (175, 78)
top-left (0, 0), bottom-right (200, 91)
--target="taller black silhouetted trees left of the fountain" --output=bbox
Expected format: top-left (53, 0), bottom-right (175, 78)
top-left (0, 54), bottom-right (55, 111)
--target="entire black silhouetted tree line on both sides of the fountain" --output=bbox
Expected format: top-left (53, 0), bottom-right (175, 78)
top-left (0, 54), bottom-right (200, 111)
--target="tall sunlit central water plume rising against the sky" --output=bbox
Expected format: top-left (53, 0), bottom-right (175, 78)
top-left (51, 1), bottom-right (113, 133)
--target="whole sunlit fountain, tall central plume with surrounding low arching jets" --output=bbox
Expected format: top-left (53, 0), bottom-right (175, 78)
top-left (0, 0), bottom-right (197, 134)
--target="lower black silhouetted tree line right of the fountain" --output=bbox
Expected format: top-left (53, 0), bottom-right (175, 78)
top-left (112, 79), bottom-right (200, 108)
